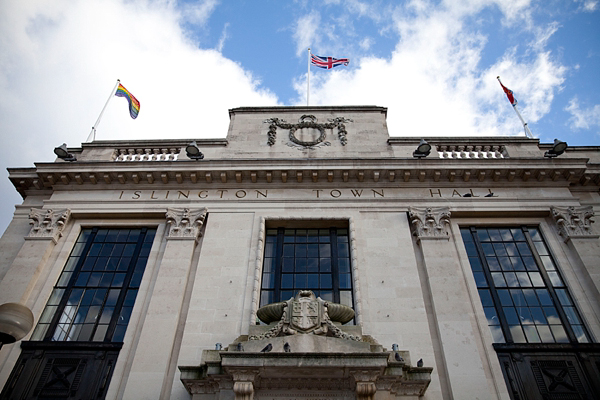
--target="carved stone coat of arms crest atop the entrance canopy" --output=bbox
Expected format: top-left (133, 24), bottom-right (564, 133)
top-left (249, 290), bottom-right (362, 341)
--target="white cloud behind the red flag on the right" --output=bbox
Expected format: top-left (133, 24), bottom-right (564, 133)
top-left (295, 0), bottom-right (567, 136)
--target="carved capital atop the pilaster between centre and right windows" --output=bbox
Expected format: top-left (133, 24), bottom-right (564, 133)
top-left (408, 207), bottom-right (450, 240)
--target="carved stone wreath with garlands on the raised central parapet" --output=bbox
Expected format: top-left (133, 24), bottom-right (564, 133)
top-left (264, 114), bottom-right (352, 148)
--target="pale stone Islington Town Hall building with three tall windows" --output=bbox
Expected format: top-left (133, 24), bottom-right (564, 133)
top-left (0, 106), bottom-right (600, 400)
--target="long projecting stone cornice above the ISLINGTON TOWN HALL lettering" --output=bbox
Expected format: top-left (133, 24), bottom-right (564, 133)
top-left (9, 158), bottom-right (600, 197)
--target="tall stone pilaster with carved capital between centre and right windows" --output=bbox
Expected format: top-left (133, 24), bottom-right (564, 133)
top-left (408, 207), bottom-right (495, 399)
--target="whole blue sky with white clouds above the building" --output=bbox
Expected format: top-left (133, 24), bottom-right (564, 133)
top-left (0, 0), bottom-right (600, 236)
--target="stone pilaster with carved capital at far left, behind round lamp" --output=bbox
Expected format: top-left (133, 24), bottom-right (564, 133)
top-left (0, 208), bottom-right (71, 307)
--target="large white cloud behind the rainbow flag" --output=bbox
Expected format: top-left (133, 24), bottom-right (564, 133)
top-left (0, 0), bottom-right (278, 231)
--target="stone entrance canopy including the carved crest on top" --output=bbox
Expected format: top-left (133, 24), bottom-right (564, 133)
top-left (179, 291), bottom-right (433, 400)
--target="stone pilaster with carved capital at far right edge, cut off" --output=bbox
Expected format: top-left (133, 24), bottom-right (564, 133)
top-left (550, 206), bottom-right (600, 292)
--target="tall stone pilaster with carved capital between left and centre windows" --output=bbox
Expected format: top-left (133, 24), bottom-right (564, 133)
top-left (123, 208), bottom-right (206, 398)
